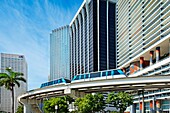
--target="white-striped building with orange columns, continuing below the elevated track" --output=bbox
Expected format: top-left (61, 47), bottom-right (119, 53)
top-left (116, 0), bottom-right (170, 113)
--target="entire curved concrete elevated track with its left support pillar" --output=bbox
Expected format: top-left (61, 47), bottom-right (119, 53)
top-left (18, 75), bottom-right (170, 113)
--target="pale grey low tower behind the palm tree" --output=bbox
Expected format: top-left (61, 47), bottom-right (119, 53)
top-left (0, 53), bottom-right (27, 112)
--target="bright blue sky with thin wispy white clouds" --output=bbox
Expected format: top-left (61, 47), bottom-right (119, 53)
top-left (0, 0), bottom-right (83, 89)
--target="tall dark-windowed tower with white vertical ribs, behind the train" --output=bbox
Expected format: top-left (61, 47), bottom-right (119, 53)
top-left (70, 0), bottom-right (116, 77)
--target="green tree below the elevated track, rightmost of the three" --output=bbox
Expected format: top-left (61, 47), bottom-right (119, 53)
top-left (106, 92), bottom-right (133, 113)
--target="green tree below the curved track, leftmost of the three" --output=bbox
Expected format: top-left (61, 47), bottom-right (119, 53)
top-left (43, 96), bottom-right (73, 113)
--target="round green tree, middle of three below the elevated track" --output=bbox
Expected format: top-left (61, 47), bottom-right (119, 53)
top-left (75, 93), bottom-right (105, 113)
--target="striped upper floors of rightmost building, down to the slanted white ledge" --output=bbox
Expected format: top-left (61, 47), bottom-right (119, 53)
top-left (117, 0), bottom-right (170, 71)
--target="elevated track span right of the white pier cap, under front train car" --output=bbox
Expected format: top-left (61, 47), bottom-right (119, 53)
top-left (70, 75), bottom-right (170, 93)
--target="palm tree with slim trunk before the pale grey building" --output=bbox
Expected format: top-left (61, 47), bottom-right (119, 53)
top-left (0, 68), bottom-right (26, 113)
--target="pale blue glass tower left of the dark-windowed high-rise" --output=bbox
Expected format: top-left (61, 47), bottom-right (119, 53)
top-left (49, 26), bottom-right (70, 80)
